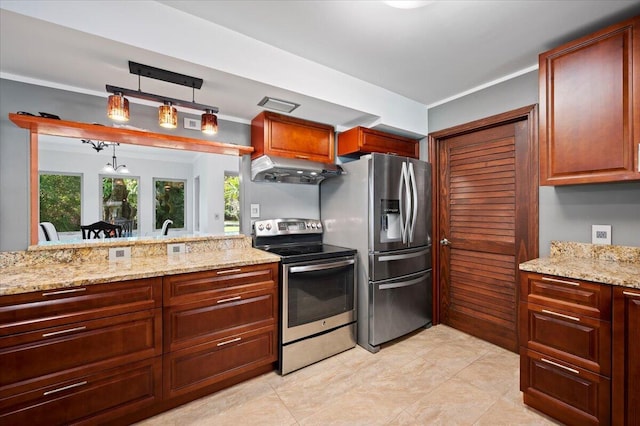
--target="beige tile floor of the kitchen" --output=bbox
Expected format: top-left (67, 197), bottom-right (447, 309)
top-left (139, 325), bottom-right (560, 426)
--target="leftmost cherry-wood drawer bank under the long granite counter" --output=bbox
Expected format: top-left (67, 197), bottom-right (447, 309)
top-left (0, 278), bottom-right (162, 426)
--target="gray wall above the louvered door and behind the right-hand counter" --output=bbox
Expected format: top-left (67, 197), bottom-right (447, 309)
top-left (429, 71), bottom-right (640, 256)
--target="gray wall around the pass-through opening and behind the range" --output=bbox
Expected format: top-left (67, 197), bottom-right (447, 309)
top-left (0, 79), bottom-right (319, 251)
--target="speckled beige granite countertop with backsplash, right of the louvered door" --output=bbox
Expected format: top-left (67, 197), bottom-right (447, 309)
top-left (520, 241), bottom-right (640, 288)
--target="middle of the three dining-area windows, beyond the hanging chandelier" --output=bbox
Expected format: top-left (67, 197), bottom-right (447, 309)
top-left (101, 176), bottom-right (138, 237)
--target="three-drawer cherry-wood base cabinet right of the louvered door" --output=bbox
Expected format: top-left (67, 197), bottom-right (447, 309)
top-left (519, 272), bottom-right (612, 425)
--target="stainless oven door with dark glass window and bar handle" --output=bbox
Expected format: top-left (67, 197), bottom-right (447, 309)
top-left (282, 256), bottom-right (356, 343)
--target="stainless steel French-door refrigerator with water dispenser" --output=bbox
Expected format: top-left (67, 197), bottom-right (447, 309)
top-left (320, 154), bottom-right (433, 352)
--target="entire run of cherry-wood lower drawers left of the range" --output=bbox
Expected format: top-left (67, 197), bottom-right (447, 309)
top-left (0, 263), bottom-right (278, 426)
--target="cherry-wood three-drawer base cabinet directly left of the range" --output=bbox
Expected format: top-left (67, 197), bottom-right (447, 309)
top-left (163, 263), bottom-right (278, 400)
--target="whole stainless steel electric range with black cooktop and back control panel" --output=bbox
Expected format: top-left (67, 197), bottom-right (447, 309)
top-left (253, 219), bottom-right (357, 375)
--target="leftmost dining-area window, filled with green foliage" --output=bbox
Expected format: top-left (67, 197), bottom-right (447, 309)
top-left (40, 173), bottom-right (82, 232)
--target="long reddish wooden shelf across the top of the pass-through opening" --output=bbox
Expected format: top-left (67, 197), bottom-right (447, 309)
top-left (9, 114), bottom-right (253, 156)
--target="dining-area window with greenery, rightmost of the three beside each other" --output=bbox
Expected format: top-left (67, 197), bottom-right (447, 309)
top-left (153, 179), bottom-right (187, 229)
